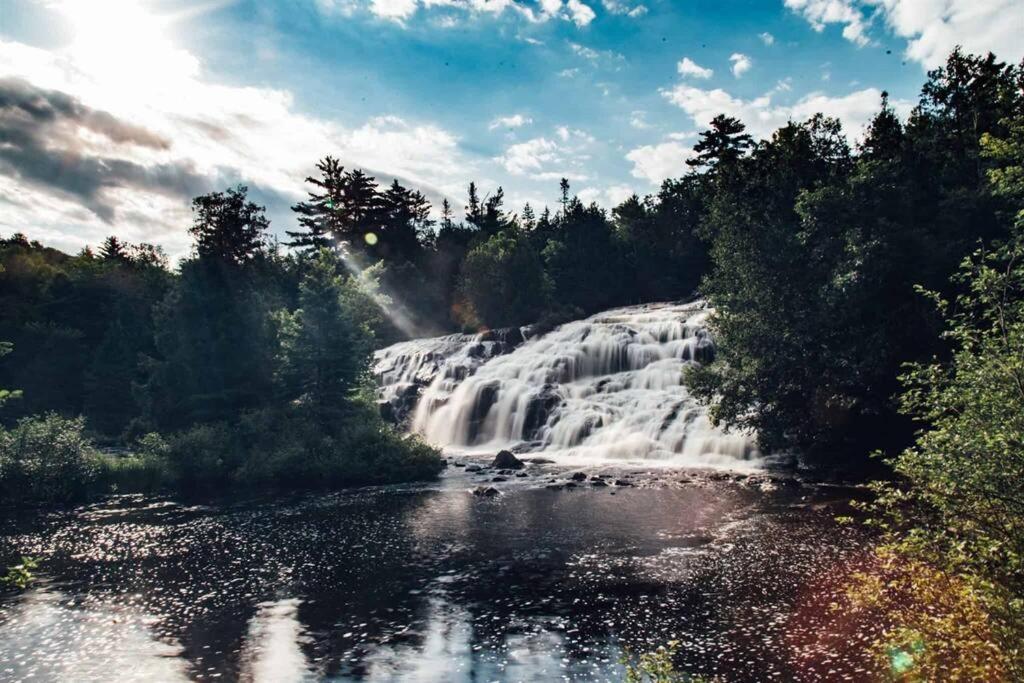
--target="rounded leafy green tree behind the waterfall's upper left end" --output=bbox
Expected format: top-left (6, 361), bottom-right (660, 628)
top-left (462, 230), bottom-right (550, 328)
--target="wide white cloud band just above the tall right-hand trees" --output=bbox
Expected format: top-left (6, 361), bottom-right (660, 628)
top-left (662, 83), bottom-right (912, 138)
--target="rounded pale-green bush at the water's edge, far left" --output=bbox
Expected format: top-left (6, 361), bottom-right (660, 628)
top-left (0, 413), bottom-right (99, 503)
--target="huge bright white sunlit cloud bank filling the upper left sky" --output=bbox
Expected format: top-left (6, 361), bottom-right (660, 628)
top-left (0, 3), bottom-right (474, 255)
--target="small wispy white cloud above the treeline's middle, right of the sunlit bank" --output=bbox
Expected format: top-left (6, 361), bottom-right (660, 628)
top-left (496, 126), bottom-right (595, 180)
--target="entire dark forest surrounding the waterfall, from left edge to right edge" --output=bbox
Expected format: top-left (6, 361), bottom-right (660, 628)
top-left (0, 50), bottom-right (1024, 680)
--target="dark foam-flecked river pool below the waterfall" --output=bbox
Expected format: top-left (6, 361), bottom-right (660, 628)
top-left (0, 468), bottom-right (880, 682)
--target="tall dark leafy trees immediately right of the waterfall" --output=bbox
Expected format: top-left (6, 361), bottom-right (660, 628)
top-left (690, 51), bottom-right (1024, 459)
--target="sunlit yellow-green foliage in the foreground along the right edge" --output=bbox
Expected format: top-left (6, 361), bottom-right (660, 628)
top-left (852, 118), bottom-right (1024, 681)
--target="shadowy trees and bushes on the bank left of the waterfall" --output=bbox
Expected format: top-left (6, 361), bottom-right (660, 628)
top-left (0, 187), bottom-right (442, 502)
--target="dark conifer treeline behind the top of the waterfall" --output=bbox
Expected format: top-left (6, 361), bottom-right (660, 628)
top-left (287, 157), bottom-right (707, 334)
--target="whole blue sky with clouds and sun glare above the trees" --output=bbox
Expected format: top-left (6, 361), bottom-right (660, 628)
top-left (0, 0), bottom-right (1024, 257)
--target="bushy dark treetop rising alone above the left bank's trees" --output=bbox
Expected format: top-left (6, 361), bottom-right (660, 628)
top-left (188, 185), bottom-right (270, 265)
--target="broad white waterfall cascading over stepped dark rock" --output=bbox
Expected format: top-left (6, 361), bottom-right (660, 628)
top-left (375, 301), bottom-right (760, 467)
